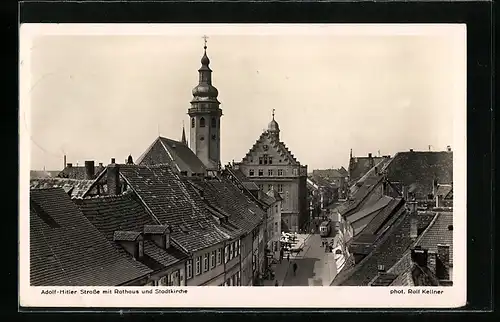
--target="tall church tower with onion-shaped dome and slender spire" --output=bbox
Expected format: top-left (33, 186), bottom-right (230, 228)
top-left (188, 36), bottom-right (222, 169)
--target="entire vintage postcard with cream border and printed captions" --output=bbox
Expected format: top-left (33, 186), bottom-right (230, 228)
top-left (19, 24), bottom-right (466, 307)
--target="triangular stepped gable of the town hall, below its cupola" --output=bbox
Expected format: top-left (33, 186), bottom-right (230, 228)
top-left (242, 131), bottom-right (299, 165)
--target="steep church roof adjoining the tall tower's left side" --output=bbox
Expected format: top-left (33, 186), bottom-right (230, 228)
top-left (137, 137), bottom-right (206, 174)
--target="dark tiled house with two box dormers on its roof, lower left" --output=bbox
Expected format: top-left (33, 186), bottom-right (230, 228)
top-left (75, 190), bottom-right (188, 286)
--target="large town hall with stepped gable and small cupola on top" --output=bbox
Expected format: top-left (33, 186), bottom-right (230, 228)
top-left (237, 111), bottom-right (308, 232)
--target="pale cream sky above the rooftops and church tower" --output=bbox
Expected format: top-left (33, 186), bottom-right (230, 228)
top-left (20, 26), bottom-right (465, 171)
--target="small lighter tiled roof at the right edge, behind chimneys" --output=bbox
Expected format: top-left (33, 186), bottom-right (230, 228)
top-left (416, 212), bottom-right (453, 263)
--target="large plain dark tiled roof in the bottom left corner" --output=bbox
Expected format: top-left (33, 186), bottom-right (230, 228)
top-left (30, 188), bottom-right (151, 286)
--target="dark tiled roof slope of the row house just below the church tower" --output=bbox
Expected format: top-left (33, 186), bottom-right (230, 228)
top-left (191, 179), bottom-right (265, 233)
